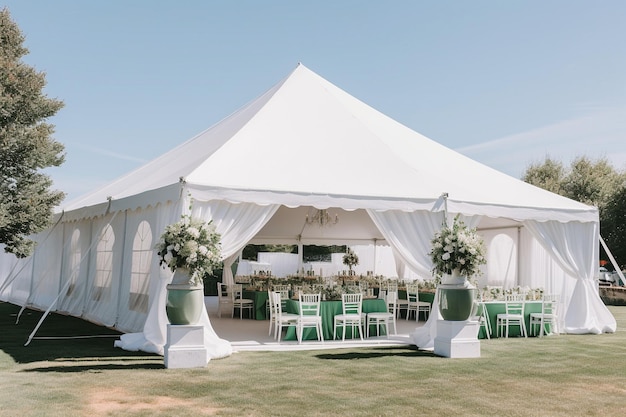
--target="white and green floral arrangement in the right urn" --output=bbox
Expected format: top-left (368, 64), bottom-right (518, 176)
top-left (429, 215), bottom-right (486, 278)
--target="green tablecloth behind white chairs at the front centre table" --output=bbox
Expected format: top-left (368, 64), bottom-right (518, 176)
top-left (283, 299), bottom-right (387, 340)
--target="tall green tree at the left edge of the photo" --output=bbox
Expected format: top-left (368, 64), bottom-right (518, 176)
top-left (0, 8), bottom-right (65, 257)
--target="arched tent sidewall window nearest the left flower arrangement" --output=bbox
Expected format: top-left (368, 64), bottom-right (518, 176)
top-left (128, 220), bottom-right (154, 313)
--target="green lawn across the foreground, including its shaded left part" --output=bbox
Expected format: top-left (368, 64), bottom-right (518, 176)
top-left (0, 303), bottom-right (626, 417)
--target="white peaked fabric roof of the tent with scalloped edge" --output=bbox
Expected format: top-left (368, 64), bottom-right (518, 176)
top-left (64, 64), bottom-right (597, 221)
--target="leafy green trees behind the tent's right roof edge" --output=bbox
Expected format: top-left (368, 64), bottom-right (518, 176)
top-left (522, 156), bottom-right (626, 265)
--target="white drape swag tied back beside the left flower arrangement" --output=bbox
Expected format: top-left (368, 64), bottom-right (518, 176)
top-left (191, 200), bottom-right (280, 284)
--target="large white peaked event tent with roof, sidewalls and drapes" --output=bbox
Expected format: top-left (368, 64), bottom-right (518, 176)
top-left (0, 64), bottom-right (616, 357)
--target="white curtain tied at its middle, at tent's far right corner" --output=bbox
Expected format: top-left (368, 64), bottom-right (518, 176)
top-left (524, 221), bottom-right (617, 334)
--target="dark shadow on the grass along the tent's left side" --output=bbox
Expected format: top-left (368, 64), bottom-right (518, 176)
top-left (0, 302), bottom-right (157, 367)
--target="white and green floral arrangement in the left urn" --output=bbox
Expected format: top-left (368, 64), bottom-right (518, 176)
top-left (155, 215), bottom-right (221, 285)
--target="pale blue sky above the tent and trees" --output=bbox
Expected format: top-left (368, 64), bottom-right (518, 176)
top-left (0, 0), bottom-right (626, 200)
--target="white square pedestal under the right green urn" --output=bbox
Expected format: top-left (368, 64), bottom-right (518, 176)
top-left (435, 320), bottom-right (480, 358)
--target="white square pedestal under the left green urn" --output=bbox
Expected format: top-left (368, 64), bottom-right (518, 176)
top-left (164, 324), bottom-right (208, 368)
